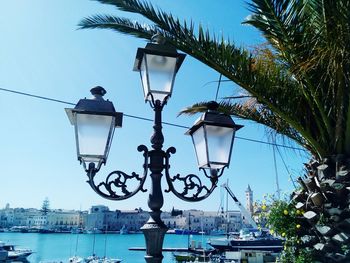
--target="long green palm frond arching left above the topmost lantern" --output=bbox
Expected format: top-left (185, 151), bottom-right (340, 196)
top-left (80, 0), bottom-right (327, 158)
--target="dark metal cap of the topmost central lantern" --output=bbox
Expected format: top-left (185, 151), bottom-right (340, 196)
top-left (133, 43), bottom-right (186, 72)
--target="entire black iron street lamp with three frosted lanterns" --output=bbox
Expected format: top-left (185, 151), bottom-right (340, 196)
top-left (66, 39), bottom-right (242, 263)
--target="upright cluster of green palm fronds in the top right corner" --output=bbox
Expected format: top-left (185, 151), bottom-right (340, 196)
top-left (246, 0), bottom-right (350, 157)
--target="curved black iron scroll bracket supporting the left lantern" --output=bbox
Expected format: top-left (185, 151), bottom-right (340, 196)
top-left (86, 145), bottom-right (148, 201)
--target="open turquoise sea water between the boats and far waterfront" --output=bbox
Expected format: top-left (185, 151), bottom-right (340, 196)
top-left (0, 232), bottom-right (208, 263)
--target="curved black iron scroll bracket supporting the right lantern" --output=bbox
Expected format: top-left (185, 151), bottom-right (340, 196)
top-left (165, 147), bottom-right (224, 202)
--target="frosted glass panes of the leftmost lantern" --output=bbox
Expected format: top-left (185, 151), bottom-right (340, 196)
top-left (76, 114), bottom-right (115, 162)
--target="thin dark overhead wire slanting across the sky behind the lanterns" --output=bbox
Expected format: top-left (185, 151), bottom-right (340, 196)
top-left (0, 88), bottom-right (306, 151)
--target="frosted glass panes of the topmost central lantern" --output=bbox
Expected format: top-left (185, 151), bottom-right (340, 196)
top-left (141, 54), bottom-right (177, 101)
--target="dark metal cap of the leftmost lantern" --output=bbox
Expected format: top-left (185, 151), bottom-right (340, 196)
top-left (65, 86), bottom-right (123, 127)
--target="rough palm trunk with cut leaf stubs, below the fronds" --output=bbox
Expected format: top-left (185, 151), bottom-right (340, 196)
top-left (292, 155), bottom-right (350, 262)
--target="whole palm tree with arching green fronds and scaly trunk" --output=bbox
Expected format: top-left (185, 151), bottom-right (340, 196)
top-left (79, 0), bottom-right (350, 262)
